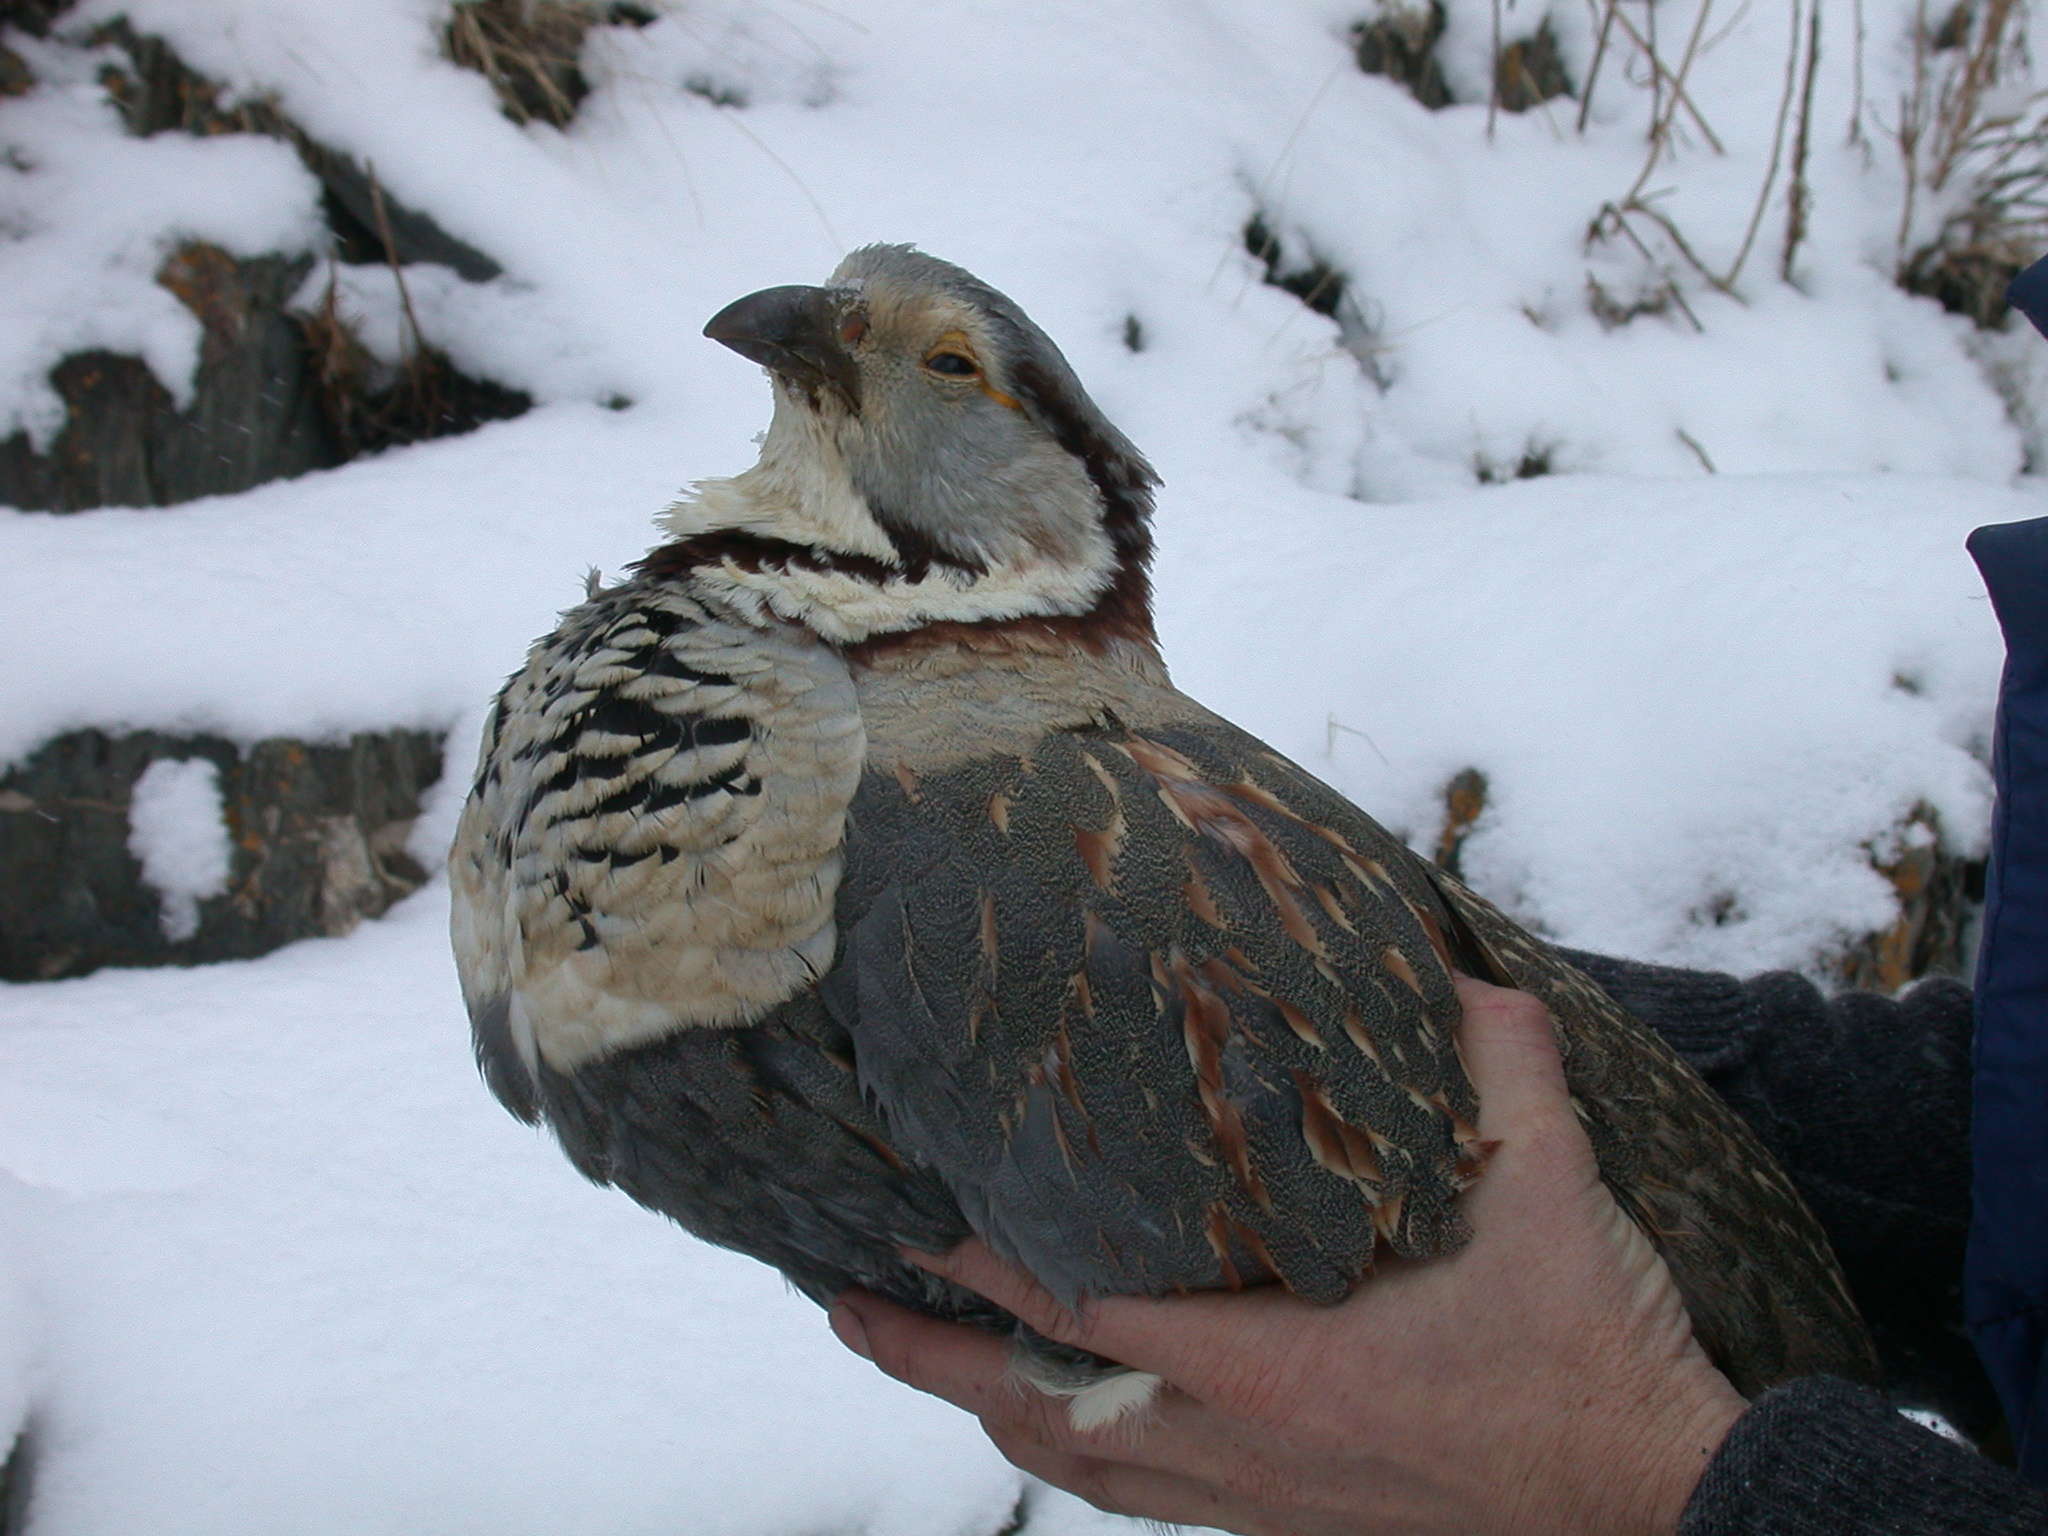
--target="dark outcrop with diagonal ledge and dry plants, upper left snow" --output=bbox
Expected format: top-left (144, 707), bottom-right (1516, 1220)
top-left (0, 20), bottom-right (532, 512)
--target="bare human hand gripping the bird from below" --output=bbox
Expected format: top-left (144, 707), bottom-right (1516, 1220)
top-left (831, 981), bottom-right (1745, 1536)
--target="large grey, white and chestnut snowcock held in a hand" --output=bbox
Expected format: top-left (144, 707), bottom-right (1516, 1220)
top-left (451, 246), bottom-right (1870, 1425)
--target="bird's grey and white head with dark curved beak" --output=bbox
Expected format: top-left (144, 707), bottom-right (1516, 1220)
top-left (672, 246), bottom-right (1157, 639)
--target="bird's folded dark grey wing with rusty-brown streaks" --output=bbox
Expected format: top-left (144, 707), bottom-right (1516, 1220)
top-left (823, 717), bottom-right (1479, 1300)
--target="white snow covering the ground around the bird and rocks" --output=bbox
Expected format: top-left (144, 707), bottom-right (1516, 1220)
top-left (0, 0), bottom-right (2048, 1536)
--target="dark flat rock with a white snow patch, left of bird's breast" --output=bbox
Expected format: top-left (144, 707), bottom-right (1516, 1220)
top-left (0, 729), bottom-right (444, 981)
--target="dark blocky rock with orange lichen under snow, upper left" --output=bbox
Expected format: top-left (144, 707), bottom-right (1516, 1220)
top-left (0, 246), bottom-right (346, 512)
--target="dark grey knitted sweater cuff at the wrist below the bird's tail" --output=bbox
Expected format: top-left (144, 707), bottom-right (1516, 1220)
top-left (1679, 1376), bottom-right (2048, 1536)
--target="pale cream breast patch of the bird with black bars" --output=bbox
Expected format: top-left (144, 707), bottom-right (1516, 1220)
top-left (451, 584), bottom-right (864, 1118)
